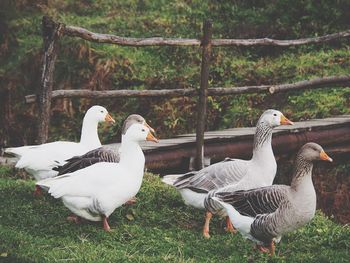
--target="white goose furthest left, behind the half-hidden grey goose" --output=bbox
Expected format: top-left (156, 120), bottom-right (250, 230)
top-left (5, 105), bottom-right (115, 194)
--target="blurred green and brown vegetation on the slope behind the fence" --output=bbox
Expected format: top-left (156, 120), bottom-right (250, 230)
top-left (0, 0), bottom-right (350, 146)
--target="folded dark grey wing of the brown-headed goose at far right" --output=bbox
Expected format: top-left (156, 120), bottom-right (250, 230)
top-left (215, 185), bottom-right (290, 217)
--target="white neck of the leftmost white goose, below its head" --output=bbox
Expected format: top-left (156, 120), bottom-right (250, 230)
top-left (80, 115), bottom-right (101, 149)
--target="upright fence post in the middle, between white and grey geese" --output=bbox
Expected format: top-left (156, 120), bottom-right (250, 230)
top-left (196, 21), bottom-right (212, 170)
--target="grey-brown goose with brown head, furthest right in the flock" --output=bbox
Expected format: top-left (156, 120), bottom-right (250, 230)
top-left (213, 142), bottom-right (333, 255)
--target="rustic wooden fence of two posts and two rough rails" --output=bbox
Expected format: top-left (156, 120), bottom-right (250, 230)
top-left (26, 16), bottom-right (350, 169)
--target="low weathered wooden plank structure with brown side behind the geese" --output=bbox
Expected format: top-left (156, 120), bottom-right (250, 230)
top-left (0, 115), bottom-right (350, 173)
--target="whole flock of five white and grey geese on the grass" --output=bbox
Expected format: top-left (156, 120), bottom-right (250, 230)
top-left (5, 106), bottom-right (332, 255)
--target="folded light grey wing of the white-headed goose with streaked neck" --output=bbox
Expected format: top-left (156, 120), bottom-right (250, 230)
top-left (174, 159), bottom-right (248, 192)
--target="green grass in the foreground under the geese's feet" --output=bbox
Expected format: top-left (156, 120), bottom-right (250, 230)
top-left (0, 170), bottom-right (350, 262)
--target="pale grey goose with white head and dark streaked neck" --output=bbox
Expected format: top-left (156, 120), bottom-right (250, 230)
top-left (162, 109), bottom-right (293, 238)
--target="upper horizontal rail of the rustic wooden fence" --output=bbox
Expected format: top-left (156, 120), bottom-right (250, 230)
top-left (64, 26), bottom-right (350, 47)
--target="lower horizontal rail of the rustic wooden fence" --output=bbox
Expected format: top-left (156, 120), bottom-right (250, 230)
top-left (25, 75), bottom-right (350, 103)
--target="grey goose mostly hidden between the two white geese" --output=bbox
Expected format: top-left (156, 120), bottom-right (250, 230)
top-left (53, 114), bottom-right (154, 175)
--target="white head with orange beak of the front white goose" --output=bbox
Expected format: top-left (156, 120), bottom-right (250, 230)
top-left (123, 123), bottom-right (158, 143)
